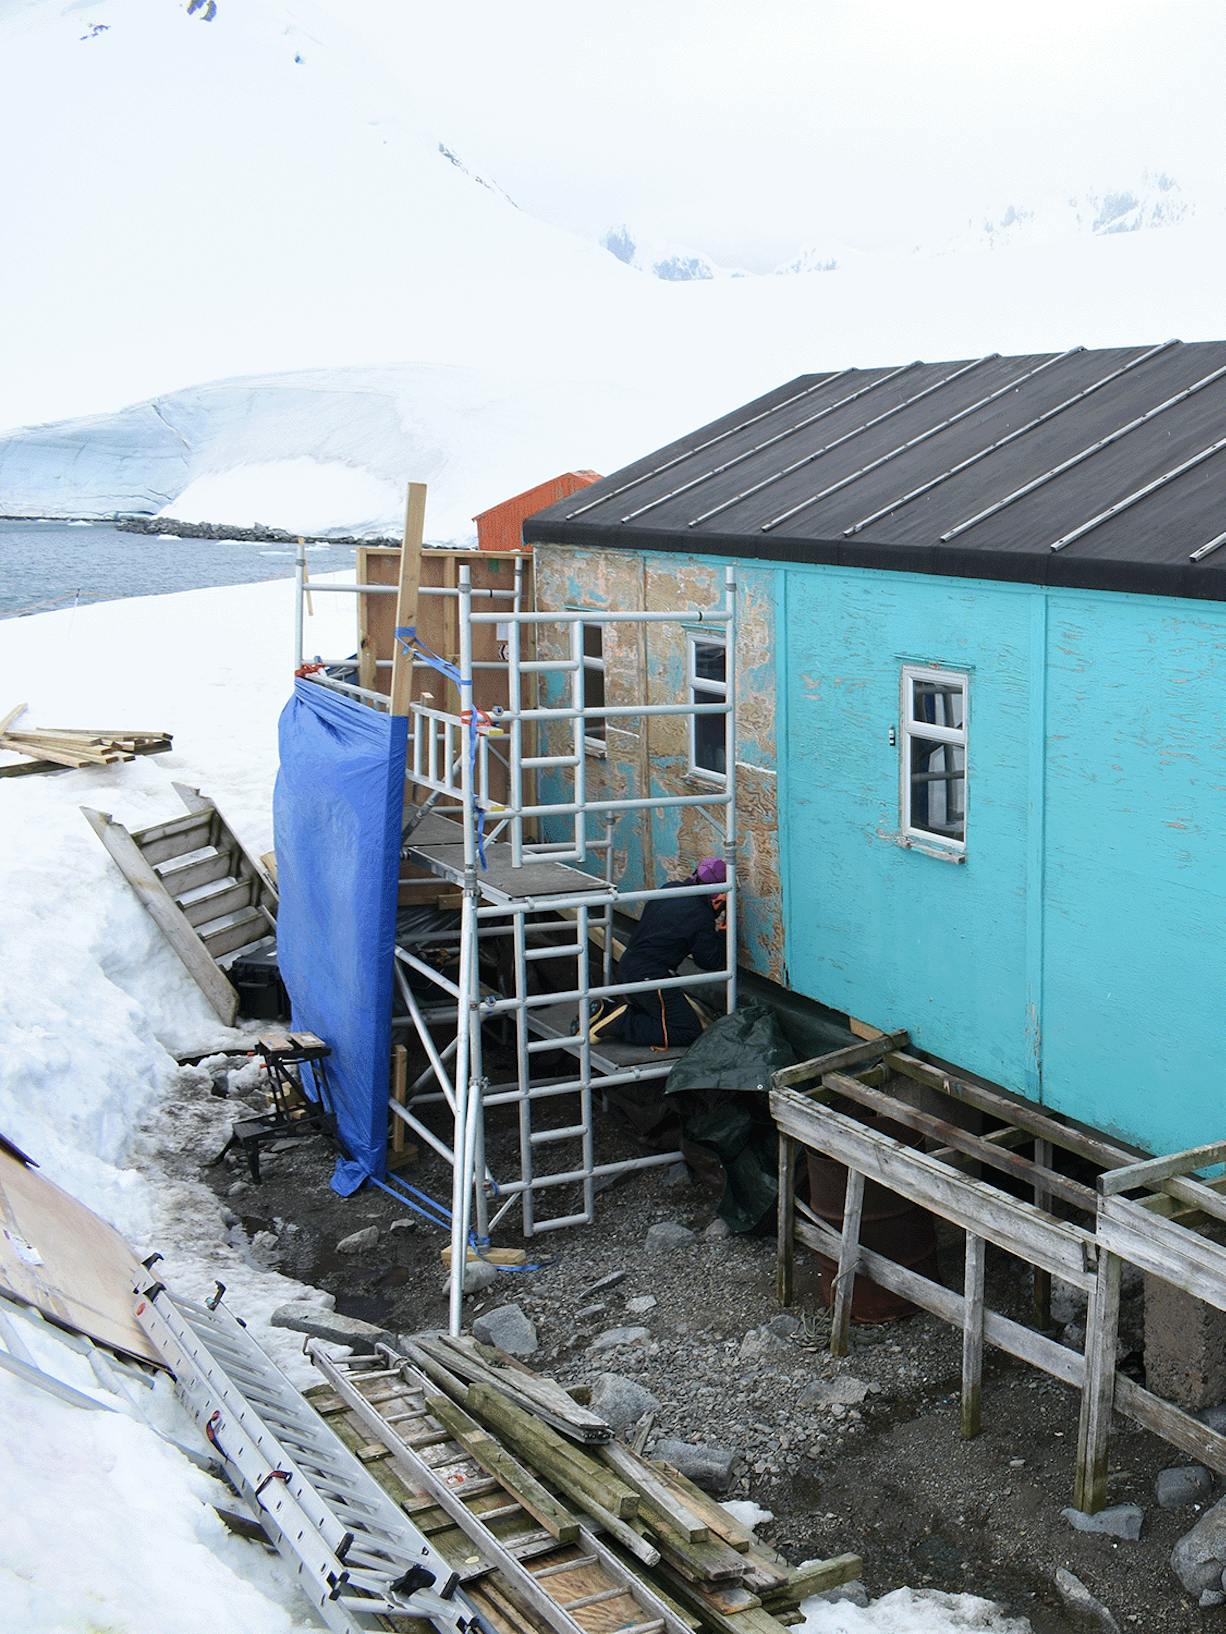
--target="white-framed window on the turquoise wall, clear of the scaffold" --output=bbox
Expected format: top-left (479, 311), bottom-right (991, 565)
top-left (899, 663), bottom-right (969, 851)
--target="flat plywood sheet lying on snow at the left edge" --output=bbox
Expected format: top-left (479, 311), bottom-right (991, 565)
top-left (0, 1149), bottom-right (165, 1368)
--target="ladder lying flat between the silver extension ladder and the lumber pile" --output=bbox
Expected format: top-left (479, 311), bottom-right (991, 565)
top-left (306, 1340), bottom-right (693, 1634)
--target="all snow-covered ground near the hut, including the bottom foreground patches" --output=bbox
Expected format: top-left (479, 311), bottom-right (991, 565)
top-left (0, 582), bottom-right (1027, 1634)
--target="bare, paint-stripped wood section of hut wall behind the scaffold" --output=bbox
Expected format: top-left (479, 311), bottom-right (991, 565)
top-left (536, 546), bottom-right (786, 980)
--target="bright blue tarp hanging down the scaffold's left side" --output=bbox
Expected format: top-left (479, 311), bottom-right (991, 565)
top-left (273, 681), bottom-right (407, 1196)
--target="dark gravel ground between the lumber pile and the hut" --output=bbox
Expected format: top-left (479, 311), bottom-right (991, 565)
top-left (204, 1071), bottom-right (1226, 1634)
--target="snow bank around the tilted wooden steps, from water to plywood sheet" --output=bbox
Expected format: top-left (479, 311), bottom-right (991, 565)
top-left (0, 580), bottom-right (355, 1376)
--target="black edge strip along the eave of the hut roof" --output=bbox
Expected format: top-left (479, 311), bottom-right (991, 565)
top-left (523, 516), bottom-right (1226, 601)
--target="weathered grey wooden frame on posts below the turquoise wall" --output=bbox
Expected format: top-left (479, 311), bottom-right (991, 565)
top-left (770, 1033), bottom-right (1226, 1513)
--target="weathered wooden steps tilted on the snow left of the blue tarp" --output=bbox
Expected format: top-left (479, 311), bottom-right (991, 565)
top-left (82, 783), bottom-right (276, 1026)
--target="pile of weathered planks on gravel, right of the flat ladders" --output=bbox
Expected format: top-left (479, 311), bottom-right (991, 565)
top-left (409, 1337), bottom-right (861, 1634)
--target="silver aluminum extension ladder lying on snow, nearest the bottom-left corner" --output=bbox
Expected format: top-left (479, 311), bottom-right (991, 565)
top-left (136, 1257), bottom-right (492, 1634)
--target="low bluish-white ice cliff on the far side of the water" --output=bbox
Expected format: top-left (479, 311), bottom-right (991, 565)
top-left (0, 364), bottom-right (695, 542)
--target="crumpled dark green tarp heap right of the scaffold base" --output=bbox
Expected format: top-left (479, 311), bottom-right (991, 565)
top-left (664, 998), bottom-right (796, 1232)
